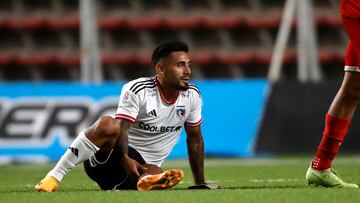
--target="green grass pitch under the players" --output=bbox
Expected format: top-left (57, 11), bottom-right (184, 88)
top-left (0, 156), bottom-right (360, 203)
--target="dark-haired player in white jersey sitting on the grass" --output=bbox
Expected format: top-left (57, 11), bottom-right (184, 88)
top-left (35, 41), bottom-right (205, 192)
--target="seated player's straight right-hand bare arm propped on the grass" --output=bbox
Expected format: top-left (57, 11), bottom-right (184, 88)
top-left (185, 126), bottom-right (205, 184)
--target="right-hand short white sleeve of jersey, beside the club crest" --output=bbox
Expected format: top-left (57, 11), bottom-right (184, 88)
top-left (185, 89), bottom-right (203, 126)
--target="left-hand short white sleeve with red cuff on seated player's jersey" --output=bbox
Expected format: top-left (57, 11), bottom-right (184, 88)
top-left (115, 86), bottom-right (140, 122)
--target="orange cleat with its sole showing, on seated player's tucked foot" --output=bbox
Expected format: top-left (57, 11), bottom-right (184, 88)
top-left (137, 169), bottom-right (184, 190)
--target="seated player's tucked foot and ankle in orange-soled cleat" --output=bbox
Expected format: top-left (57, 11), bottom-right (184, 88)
top-left (137, 164), bottom-right (184, 190)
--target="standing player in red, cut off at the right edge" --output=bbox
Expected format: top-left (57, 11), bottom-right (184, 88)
top-left (306, 0), bottom-right (360, 188)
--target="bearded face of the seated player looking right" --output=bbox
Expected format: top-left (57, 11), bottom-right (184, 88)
top-left (164, 51), bottom-right (191, 90)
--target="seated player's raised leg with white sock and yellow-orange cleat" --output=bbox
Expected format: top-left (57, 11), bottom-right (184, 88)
top-left (35, 117), bottom-right (119, 192)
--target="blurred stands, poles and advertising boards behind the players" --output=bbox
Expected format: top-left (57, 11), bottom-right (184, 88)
top-left (0, 0), bottom-right (360, 163)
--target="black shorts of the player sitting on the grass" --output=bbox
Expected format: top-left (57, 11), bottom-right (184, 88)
top-left (84, 147), bottom-right (145, 190)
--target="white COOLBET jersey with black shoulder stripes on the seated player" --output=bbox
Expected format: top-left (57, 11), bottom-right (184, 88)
top-left (115, 77), bottom-right (203, 166)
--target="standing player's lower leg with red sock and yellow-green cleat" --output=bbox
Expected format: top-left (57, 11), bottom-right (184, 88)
top-left (306, 72), bottom-right (360, 188)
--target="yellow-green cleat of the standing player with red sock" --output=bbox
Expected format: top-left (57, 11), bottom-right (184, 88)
top-left (306, 166), bottom-right (359, 189)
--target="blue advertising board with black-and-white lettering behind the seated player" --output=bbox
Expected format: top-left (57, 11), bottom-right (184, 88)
top-left (0, 80), bottom-right (269, 162)
